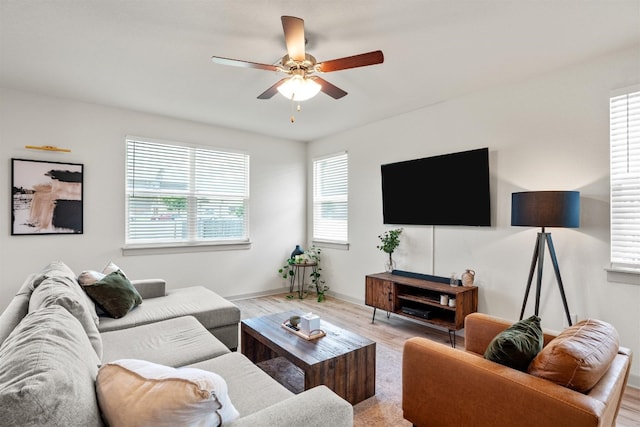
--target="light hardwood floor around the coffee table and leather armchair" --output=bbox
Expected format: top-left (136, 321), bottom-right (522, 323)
top-left (234, 294), bottom-right (640, 427)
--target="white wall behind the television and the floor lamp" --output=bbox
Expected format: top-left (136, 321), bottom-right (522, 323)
top-left (307, 49), bottom-right (640, 386)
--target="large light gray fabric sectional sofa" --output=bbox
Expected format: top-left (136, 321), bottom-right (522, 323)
top-left (0, 262), bottom-right (353, 427)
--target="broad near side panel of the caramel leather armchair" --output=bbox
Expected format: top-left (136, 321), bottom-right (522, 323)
top-left (402, 338), bottom-right (607, 427)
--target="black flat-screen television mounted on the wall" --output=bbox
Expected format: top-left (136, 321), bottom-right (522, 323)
top-left (380, 148), bottom-right (491, 226)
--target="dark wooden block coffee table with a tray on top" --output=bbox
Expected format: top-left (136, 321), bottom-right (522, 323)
top-left (240, 311), bottom-right (376, 405)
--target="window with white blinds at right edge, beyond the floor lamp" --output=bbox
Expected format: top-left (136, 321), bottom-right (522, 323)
top-left (609, 87), bottom-right (640, 269)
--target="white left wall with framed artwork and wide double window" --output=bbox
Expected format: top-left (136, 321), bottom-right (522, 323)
top-left (0, 89), bottom-right (306, 310)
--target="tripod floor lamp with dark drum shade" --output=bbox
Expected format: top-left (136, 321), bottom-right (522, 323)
top-left (511, 191), bottom-right (580, 326)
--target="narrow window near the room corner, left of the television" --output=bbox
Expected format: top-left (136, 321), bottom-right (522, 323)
top-left (313, 153), bottom-right (349, 243)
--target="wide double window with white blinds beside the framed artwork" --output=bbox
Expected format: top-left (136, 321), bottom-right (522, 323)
top-left (126, 138), bottom-right (249, 246)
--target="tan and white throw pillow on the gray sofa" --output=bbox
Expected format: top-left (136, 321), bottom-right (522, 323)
top-left (96, 359), bottom-right (239, 427)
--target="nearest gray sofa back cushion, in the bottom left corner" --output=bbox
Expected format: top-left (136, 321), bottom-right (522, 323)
top-left (0, 305), bottom-right (102, 427)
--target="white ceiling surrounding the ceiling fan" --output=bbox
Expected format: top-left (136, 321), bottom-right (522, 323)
top-left (0, 0), bottom-right (640, 141)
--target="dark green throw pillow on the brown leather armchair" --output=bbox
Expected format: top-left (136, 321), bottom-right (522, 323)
top-left (484, 316), bottom-right (544, 372)
